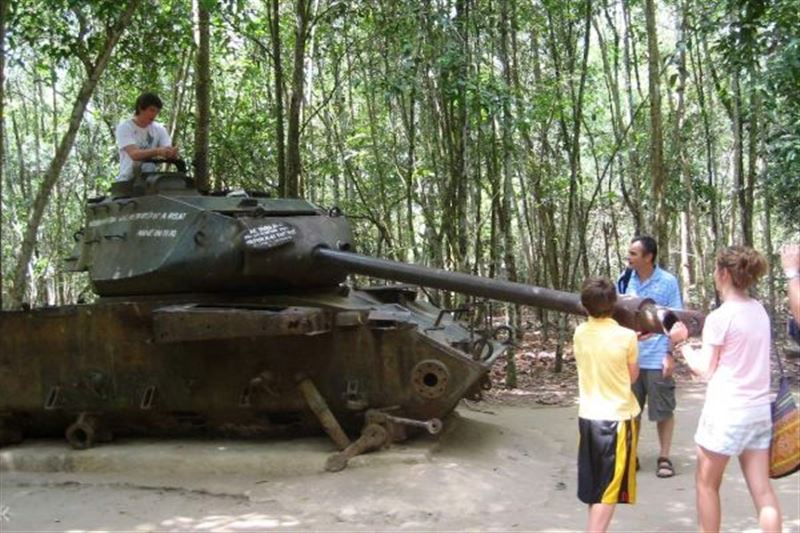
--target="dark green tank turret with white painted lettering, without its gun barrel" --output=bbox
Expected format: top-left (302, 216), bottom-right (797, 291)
top-left (69, 158), bottom-right (352, 296)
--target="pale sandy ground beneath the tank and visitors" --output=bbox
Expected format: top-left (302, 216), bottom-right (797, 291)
top-left (0, 385), bottom-right (800, 532)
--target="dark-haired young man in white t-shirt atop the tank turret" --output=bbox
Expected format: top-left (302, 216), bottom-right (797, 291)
top-left (116, 93), bottom-right (178, 181)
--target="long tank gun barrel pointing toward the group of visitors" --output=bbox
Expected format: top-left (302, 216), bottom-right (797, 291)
top-left (314, 248), bottom-right (705, 335)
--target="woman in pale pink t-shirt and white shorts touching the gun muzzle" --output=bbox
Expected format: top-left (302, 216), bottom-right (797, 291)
top-left (670, 246), bottom-right (781, 531)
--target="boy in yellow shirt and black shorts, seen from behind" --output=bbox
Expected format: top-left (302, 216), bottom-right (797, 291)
top-left (573, 278), bottom-right (640, 531)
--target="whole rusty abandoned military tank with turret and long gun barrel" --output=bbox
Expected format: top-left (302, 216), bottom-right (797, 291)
top-left (0, 161), bottom-right (702, 470)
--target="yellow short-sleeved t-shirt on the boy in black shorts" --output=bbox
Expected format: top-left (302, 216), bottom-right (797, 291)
top-left (573, 317), bottom-right (640, 420)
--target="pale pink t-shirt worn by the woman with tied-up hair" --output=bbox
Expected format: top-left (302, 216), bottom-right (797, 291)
top-left (703, 299), bottom-right (771, 418)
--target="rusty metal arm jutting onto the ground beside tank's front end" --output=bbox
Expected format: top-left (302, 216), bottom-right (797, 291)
top-left (325, 409), bottom-right (442, 472)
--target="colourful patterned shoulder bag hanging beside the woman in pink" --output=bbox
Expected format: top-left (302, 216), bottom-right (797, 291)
top-left (769, 372), bottom-right (800, 479)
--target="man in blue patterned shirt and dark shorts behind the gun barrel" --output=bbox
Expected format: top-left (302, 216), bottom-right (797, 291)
top-left (617, 236), bottom-right (683, 477)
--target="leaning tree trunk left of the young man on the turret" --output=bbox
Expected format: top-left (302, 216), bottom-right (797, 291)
top-left (11, 0), bottom-right (141, 308)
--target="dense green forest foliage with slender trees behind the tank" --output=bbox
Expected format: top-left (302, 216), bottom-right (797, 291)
top-left (2, 0), bottom-right (800, 303)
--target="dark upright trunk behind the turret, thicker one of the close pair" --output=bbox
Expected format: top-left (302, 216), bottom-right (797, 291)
top-left (283, 0), bottom-right (311, 198)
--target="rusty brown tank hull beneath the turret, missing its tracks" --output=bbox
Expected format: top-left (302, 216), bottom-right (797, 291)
top-left (0, 289), bottom-right (503, 442)
